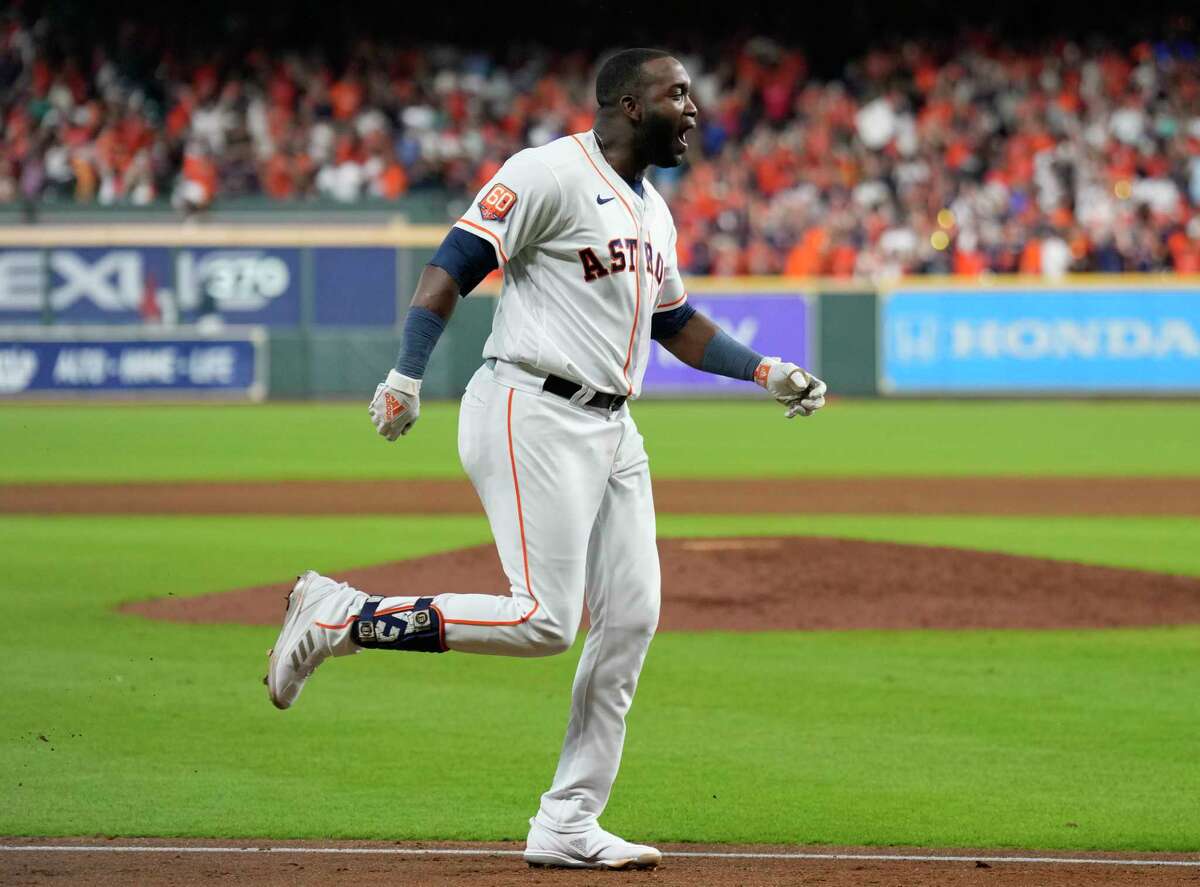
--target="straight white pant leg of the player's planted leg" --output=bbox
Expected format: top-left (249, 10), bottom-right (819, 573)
top-left (538, 412), bottom-right (660, 832)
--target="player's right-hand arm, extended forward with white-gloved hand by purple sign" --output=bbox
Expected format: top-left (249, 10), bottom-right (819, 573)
top-left (650, 302), bottom-right (826, 419)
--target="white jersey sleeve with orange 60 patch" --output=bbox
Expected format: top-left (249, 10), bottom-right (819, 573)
top-left (455, 150), bottom-right (563, 268)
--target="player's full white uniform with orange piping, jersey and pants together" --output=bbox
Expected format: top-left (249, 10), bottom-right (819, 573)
top-left (350, 132), bottom-right (686, 832)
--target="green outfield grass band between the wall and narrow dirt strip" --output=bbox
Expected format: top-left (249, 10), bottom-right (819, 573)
top-left (7, 401), bottom-right (1200, 483)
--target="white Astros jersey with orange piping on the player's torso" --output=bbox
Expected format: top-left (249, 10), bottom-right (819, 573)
top-left (455, 132), bottom-right (688, 397)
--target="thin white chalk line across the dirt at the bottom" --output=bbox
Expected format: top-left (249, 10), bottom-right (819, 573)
top-left (0, 844), bottom-right (1200, 868)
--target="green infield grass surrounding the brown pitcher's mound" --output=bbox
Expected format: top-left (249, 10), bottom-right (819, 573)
top-left (0, 516), bottom-right (1200, 851)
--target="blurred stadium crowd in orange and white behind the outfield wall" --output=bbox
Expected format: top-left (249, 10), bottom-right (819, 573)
top-left (0, 20), bottom-right (1200, 277)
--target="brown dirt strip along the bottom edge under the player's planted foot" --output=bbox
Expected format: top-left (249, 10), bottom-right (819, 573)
top-left (0, 839), bottom-right (1200, 887)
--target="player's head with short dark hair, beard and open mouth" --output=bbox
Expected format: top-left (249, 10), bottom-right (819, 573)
top-left (596, 49), bottom-right (696, 167)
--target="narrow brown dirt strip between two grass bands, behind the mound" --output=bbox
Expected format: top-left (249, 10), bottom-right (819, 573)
top-left (7, 478), bottom-right (1200, 515)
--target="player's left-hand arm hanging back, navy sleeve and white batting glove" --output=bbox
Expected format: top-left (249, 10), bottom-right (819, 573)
top-left (367, 228), bottom-right (498, 440)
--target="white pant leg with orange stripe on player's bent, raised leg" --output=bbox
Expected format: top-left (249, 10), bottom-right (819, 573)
top-left (348, 366), bottom-right (623, 657)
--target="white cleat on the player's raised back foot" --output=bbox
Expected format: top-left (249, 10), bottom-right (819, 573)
top-left (270, 570), bottom-right (366, 709)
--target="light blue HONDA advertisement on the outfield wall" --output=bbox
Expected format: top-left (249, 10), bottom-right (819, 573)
top-left (880, 287), bottom-right (1200, 395)
